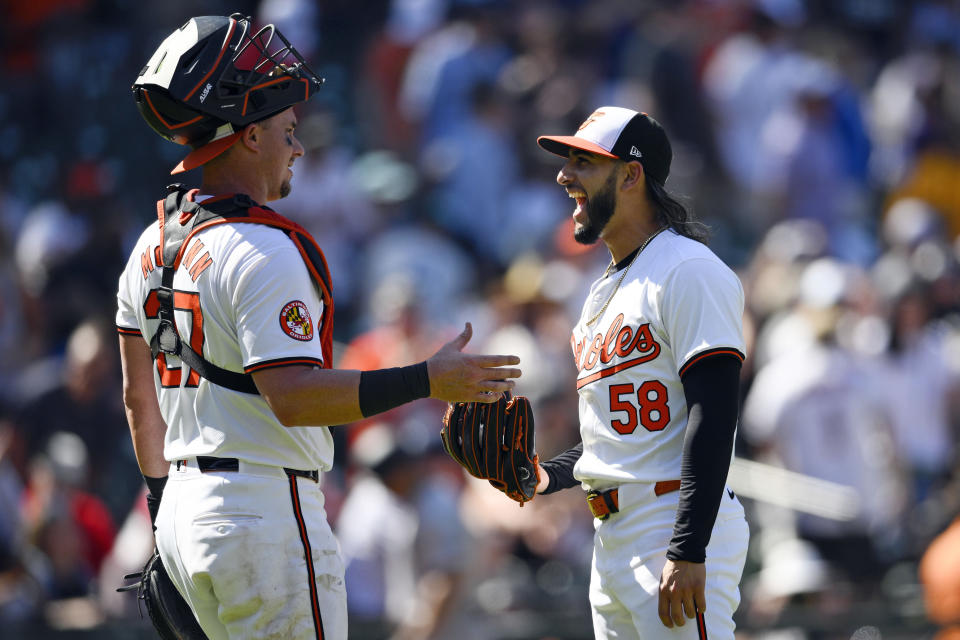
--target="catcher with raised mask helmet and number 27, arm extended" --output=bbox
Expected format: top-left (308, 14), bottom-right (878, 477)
top-left (116, 14), bottom-right (520, 640)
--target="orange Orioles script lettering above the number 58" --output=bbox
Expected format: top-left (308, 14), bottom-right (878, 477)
top-left (570, 313), bottom-right (660, 389)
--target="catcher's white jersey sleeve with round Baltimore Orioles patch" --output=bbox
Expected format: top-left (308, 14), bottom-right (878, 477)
top-left (233, 240), bottom-right (323, 373)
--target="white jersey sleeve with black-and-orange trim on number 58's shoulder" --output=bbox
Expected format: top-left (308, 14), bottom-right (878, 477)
top-left (661, 258), bottom-right (746, 377)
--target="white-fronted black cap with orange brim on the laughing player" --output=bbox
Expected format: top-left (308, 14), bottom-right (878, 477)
top-left (537, 107), bottom-right (673, 185)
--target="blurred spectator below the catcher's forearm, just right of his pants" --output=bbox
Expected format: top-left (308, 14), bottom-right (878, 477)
top-left (337, 422), bottom-right (472, 640)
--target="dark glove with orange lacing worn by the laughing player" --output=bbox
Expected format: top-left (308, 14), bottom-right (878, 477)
top-left (440, 396), bottom-right (540, 506)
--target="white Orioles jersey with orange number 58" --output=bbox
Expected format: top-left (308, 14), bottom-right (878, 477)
top-left (571, 230), bottom-right (745, 490)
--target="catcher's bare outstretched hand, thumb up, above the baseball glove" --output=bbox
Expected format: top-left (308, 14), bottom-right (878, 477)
top-left (427, 322), bottom-right (520, 402)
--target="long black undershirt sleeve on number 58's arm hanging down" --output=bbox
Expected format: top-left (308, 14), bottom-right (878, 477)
top-left (667, 354), bottom-right (741, 562)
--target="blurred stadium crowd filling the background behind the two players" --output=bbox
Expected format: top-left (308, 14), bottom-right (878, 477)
top-left (0, 0), bottom-right (960, 640)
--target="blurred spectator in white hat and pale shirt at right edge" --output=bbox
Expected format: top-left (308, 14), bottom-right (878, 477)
top-left (872, 198), bottom-right (960, 520)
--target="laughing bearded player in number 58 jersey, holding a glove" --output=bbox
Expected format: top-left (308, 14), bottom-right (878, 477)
top-left (442, 107), bottom-right (749, 640)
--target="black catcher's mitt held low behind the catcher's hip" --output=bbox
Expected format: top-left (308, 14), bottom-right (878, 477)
top-left (117, 549), bottom-right (207, 640)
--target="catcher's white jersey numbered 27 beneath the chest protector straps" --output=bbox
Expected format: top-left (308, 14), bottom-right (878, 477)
top-left (116, 202), bottom-right (333, 471)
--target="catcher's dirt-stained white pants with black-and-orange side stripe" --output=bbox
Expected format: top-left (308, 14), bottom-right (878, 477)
top-left (156, 459), bottom-right (347, 640)
